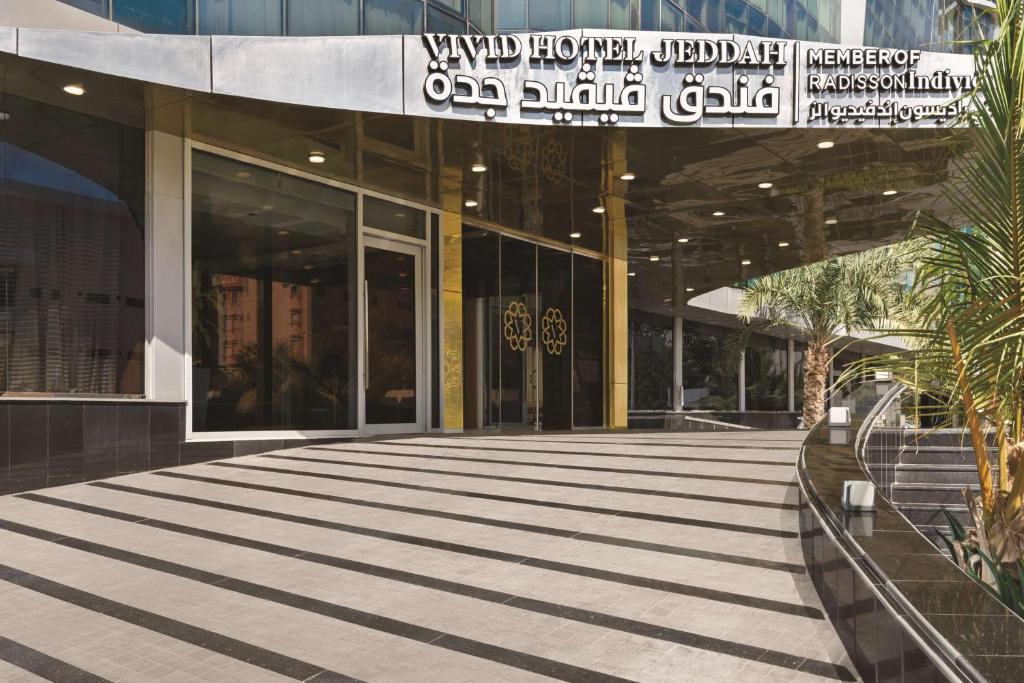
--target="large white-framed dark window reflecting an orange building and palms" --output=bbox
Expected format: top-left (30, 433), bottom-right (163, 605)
top-left (191, 152), bottom-right (360, 431)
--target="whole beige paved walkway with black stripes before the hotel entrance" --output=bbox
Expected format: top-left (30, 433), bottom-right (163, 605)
top-left (0, 432), bottom-right (854, 683)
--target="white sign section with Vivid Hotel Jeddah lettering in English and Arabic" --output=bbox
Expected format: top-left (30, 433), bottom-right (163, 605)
top-left (404, 32), bottom-right (975, 127)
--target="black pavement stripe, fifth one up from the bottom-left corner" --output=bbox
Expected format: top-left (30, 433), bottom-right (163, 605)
top-left (70, 481), bottom-right (824, 620)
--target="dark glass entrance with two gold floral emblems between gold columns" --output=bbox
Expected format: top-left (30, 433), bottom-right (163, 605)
top-left (462, 226), bottom-right (604, 429)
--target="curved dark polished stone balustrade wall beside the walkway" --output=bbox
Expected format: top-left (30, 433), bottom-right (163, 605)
top-left (798, 387), bottom-right (1024, 683)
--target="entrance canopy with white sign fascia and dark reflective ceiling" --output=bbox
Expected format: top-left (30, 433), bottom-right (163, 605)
top-left (0, 29), bottom-right (973, 311)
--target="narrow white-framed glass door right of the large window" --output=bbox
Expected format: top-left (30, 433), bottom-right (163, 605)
top-left (361, 236), bottom-right (426, 434)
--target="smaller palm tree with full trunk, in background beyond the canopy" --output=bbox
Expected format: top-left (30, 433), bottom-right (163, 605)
top-left (739, 243), bottom-right (916, 428)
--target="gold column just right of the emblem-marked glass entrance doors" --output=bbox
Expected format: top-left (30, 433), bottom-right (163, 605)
top-left (603, 130), bottom-right (630, 429)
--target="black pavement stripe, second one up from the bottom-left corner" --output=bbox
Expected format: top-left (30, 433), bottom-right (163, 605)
top-left (0, 565), bottom-right (358, 683)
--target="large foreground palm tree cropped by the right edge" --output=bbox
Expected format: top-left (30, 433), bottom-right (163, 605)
top-left (862, 0), bottom-right (1024, 583)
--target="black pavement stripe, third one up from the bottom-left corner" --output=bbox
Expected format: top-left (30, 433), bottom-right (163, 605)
top-left (0, 520), bottom-right (630, 683)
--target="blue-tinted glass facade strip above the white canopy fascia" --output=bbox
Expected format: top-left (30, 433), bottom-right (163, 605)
top-left (54, 0), bottom-right (992, 51)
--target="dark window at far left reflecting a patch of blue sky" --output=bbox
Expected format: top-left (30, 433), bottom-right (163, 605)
top-left (0, 93), bottom-right (145, 395)
